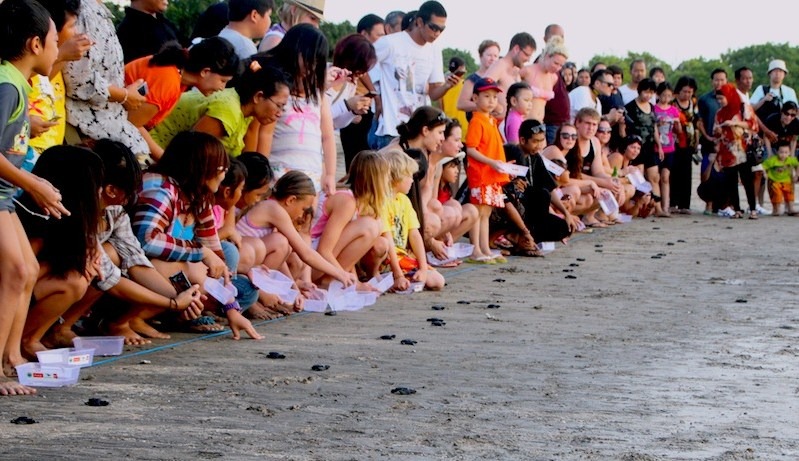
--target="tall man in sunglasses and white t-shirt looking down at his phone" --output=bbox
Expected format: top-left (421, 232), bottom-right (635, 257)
top-left (369, 0), bottom-right (460, 148)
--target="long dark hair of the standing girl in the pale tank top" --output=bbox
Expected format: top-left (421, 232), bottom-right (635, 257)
top-left (254, 24), bottom-right (330, 104)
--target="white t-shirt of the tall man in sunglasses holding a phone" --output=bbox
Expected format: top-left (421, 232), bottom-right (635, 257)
top-left (369, 32), bottom-right (444, 136)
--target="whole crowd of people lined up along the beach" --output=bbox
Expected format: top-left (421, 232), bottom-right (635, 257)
top-left (0, 0), bottom-right (799, 395)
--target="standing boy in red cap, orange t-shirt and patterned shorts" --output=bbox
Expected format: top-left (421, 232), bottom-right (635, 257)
top-left (465, 78), bottom-right (510, 264)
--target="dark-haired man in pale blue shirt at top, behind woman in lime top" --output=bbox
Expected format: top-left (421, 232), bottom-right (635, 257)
top-left (219, 0), bottom-right (275, 59)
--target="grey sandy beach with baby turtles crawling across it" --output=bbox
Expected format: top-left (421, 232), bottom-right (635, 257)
top-left (0, 207), bottom-right (799, 461)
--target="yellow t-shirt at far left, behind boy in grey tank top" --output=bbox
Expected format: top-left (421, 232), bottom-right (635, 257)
top-left (28, 72), bottom-right (67, 154)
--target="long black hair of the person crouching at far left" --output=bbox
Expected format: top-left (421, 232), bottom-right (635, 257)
top-left (19, 146), bottom-right (103, 277)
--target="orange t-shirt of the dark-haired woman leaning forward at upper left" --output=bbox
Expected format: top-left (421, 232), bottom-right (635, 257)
top-left (125, 56), bottom-right (186, 131)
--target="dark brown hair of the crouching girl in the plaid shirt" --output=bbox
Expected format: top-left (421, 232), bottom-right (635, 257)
top-left (150, 131), bottom-right (230, 217)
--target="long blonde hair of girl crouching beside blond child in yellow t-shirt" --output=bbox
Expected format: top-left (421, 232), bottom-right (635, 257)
top-left (348, 150), bottom-right (393, 218)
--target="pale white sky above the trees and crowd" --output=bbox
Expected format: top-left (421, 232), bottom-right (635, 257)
top-left (325, 0), bottom-right (799, 71)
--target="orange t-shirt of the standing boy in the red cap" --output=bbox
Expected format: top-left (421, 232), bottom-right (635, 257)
top-left (464, 112), bottom-right (510, 188)
